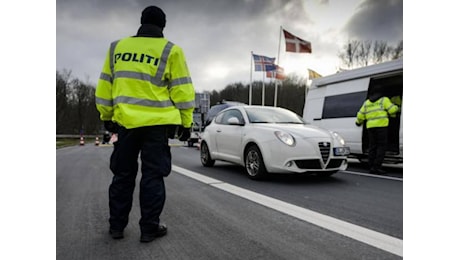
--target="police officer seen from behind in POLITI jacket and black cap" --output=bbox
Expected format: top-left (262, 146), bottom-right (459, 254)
top-left (96, 6), bottom-right (195, 242)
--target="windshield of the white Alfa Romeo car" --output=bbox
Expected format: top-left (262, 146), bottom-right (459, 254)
top-left (246, 107), bottom-right (305, 124)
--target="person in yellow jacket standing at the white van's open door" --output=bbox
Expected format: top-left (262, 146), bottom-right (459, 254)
top-left (356, 86), bottom-right (399, 174)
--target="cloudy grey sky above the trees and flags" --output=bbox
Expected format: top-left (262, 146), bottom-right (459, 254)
top-left (56, 0), bottom-right (403, 91)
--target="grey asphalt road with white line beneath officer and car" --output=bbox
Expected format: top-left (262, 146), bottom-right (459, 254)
top-left (56, 144), bottom-right (403, 259)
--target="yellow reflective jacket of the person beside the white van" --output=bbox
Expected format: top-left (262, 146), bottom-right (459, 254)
top-left (356, 97), bottom-right (399, 128)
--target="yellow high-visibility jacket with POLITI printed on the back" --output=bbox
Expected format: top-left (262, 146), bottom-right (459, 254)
top-left (96, 37), bottom-right (195, 129)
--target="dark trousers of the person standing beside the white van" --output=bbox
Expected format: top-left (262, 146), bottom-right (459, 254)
top-left (367, 127), bottom-right (388, 170)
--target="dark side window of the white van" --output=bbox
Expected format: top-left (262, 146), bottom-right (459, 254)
top-left (322, 91), bottom-right (367, 118)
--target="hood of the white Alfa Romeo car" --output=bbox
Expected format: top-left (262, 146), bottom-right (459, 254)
top-left (254, 124), bottom-right (331, 138)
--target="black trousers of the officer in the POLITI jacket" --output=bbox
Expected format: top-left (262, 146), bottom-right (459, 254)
top-left (109, 126), bottom-right (171, 233)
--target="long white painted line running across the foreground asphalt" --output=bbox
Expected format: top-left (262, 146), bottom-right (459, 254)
top-left (172, 165), bottom-right (403, 257)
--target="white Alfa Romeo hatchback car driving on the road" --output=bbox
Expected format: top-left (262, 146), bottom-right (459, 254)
top-left (200, 105), bottom-right (350, 179)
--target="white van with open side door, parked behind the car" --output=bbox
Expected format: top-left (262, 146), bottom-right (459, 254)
top-left (303, 59), bottom-right (403, 163)
